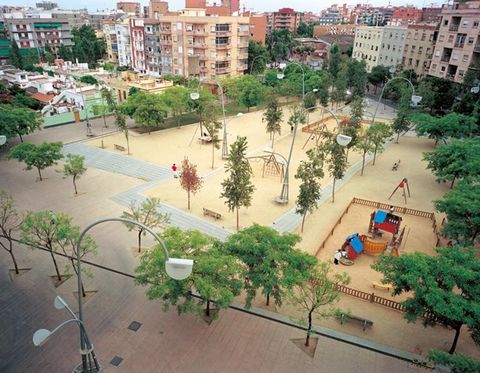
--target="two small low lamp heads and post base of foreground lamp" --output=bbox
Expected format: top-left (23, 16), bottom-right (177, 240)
top-left (32, 296), bottom-right (102, 373)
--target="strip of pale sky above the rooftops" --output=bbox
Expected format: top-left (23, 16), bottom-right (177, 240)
top-left (0, 0), bottom-right (441, 13)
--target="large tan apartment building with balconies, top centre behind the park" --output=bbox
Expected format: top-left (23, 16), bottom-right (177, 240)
top-left (148, 9), bottom-right (250, 79)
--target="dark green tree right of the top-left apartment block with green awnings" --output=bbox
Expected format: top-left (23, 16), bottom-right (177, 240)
top-left (72, 25), bottom-right (105, 68)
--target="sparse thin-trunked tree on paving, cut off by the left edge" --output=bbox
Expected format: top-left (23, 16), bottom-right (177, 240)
top-left (0, 190), bottom-right (22, 275)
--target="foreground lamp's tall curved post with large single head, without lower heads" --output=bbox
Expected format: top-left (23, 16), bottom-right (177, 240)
top-left (72, 218), bottom-right (193, 373)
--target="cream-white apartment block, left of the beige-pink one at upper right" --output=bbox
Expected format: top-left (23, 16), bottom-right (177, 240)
top-left (352, 26), bottom-right (407, 71)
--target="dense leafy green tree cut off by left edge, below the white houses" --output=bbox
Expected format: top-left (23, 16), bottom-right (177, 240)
top-left (0, 104), bottom-right (43, 143)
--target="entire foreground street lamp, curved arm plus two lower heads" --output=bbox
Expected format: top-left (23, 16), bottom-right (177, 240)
top-left (33, 218), bottom-right (193, 373)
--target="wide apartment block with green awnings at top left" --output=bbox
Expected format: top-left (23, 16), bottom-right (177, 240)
top-left (5, 18), bottom-right (73, 52)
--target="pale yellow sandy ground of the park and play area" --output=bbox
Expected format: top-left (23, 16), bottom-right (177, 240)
top-left (88, 104), bottom-right (479, 355)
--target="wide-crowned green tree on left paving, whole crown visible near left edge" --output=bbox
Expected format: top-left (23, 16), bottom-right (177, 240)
top-left (8, 142), bottom-right (63, 181)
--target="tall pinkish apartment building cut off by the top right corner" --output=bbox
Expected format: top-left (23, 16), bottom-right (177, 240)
top-left (429, 0), bottom-right (480, 83)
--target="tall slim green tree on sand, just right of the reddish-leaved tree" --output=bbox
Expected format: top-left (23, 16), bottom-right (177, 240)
top-left (220, 137), bottom-right (255, 230)
